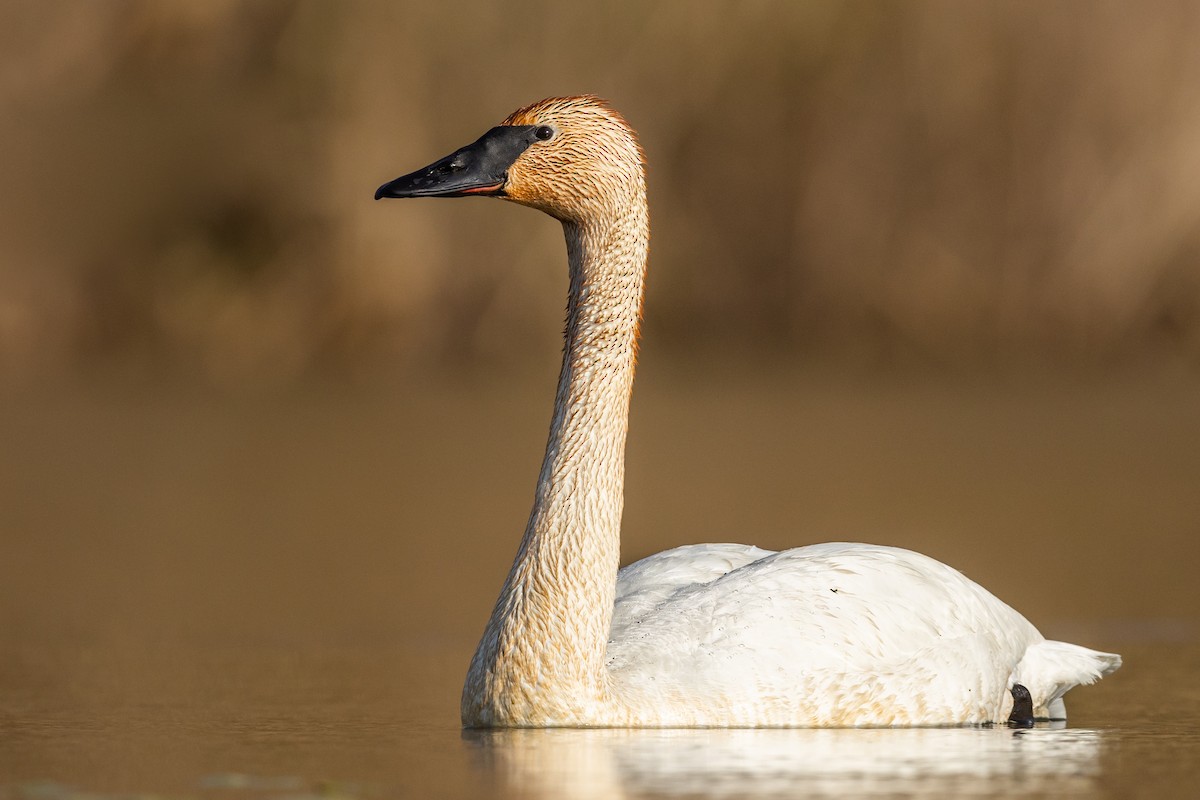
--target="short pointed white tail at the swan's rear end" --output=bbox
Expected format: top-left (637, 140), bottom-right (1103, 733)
top-left (1013, 640), bottom-right (1121, 720)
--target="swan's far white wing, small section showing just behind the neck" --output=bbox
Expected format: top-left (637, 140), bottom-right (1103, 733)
top-left (611, 545), bottom-right (775, 638)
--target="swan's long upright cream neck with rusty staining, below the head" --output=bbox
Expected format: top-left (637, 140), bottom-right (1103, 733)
top-left (462, 199), bottom-right (648, 726)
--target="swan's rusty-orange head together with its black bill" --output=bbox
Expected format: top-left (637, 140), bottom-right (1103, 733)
top-left (376, 95), bottom-right (646, 223)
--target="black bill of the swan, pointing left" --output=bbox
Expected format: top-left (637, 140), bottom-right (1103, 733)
top-left (376, 125), bottom-right (538, 200)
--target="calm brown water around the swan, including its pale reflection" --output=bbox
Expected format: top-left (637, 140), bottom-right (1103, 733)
top-left (0, 365), bottom-right (1200, 800)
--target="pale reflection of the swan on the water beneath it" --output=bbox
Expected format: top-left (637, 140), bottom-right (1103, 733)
top-left (463, 726), bottom-right (1103, 799)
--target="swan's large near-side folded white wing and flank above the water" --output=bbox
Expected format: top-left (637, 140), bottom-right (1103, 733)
top-left (608, 543), bottom-right (1042, 724)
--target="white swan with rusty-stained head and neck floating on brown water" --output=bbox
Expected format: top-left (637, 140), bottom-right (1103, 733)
top-left (376, 95), bottom-right (1121, 728)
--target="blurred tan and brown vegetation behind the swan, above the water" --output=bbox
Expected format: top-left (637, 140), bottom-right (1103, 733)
top-left (0, 0), bottom-right (1200, 380)
